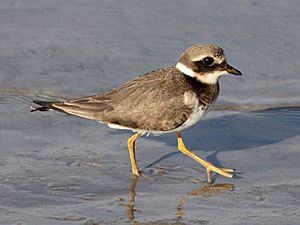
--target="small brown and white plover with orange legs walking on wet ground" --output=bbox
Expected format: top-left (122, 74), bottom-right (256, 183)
top-left (32, 44), bottom-right (242, 183)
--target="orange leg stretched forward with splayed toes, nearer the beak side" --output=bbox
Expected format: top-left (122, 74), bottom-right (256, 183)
top-left (177, 132), bottom-right (234, 183)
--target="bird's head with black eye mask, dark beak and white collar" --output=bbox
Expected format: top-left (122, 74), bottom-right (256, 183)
top-left (176, 44), bottom-right (242, 84)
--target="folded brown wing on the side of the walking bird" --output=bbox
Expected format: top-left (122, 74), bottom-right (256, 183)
top-left (52, 67), bottom-right (191, 131)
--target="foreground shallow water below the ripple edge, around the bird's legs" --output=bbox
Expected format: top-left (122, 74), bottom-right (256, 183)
top-left (0, 90), bottom-right (300, 225)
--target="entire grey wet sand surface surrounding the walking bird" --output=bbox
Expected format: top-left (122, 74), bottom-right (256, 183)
top-left (0, 0), bottom-right (300, 225)
